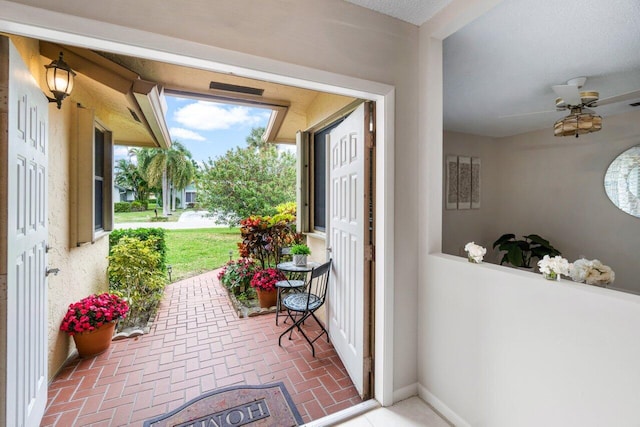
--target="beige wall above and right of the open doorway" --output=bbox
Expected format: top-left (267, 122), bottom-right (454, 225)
top-left (0, 0), bottom-right (418, 404)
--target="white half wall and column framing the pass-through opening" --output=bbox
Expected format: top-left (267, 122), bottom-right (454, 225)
top-left (418, 0), bottom-right (640, 426)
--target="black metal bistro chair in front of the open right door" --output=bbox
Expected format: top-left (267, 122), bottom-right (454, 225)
top-left (278, 260), bottom-right (331, 357)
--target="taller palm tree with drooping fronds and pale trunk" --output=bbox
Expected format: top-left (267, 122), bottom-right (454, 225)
top-left (137, 141), bottom-right (194, 216)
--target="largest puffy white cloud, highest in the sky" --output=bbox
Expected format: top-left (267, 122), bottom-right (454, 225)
top-left (173, 101), bottom-right (264, 130)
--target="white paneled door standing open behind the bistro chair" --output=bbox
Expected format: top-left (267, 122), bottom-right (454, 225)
top-left (327, 103), bottom-right (369, 396)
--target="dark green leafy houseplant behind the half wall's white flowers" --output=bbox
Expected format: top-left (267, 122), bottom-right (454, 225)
top-left (493, 234), bottom-right (560, 268)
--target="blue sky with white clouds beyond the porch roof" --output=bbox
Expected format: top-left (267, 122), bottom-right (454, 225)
top-left (115, 96), bottom-right (271, 163)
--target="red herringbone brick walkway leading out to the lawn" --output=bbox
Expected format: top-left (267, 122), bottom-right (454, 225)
top-left (41, 272), bottom-right (361, 427)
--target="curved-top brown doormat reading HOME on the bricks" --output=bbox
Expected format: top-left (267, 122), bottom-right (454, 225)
top-left (144, 382), bottom-right (302, 427)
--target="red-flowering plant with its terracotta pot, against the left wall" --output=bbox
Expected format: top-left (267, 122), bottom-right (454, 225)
top-left (60, 293), bottom-right (129, 357)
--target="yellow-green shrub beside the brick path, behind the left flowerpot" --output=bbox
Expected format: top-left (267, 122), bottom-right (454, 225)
top-left (108, 236), bottom-right (166, 327)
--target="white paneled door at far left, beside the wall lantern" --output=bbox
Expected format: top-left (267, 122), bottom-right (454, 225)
top-left (1, 42), bottom-right (49, 427)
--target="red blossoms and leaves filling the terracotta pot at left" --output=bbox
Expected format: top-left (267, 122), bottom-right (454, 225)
top-left (60, 292), bottom-right (129, 335)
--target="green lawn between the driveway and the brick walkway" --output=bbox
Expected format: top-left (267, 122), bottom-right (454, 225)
top-left (166, 228), bottom-right (240, 282)
